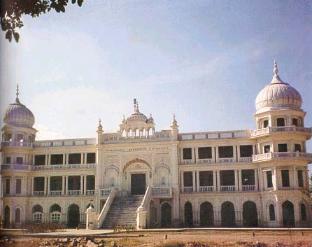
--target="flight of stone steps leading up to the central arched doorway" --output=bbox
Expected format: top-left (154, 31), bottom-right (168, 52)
top-left (102, 195), bottom-right (144, 228)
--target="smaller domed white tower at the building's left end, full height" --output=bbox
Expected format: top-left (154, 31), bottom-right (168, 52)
top-left (1, 87), bottom-right (36, 227)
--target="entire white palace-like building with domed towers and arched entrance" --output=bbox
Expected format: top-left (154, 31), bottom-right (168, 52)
top-left (0, 64), bottom-right (312, 228)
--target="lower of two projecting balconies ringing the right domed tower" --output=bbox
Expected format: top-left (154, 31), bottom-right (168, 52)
top-left (252, 152), bottom-right (312, 162)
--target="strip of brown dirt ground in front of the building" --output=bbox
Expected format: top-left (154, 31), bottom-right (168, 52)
top-left (0, 229), bottom-right (312, 247)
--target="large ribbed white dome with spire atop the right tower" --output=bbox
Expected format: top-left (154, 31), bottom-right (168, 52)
top-left (256, 62), bottom-right (302, 111)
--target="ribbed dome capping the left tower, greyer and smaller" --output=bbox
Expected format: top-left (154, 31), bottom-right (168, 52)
top-left (3, 97), bottom-right (35, 128)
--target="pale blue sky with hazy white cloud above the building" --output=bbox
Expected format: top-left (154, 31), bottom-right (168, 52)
top-left (0, 0), bottom-right (312, 156)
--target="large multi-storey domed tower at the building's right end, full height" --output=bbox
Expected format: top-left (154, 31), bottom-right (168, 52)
top-left (252, 62), bottom-right (312, 227)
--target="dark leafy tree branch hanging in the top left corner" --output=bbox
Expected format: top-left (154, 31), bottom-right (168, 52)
top-left (0, 0), bottom-right (83, 42)
